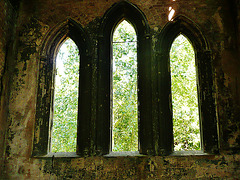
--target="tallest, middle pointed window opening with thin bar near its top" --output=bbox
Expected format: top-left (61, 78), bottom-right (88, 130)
top-left (112, 20), bottom-right (138, 152)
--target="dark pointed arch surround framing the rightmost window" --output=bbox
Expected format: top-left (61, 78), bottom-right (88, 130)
top-left (155, 16), bottom-right (218, 154)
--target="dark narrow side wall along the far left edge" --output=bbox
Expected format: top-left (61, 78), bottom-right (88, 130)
top-left (0, 0), bottom-right (16, 174)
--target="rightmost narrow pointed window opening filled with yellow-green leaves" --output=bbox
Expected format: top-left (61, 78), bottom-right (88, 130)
top-left (170, 35), bottom-right (201, 151)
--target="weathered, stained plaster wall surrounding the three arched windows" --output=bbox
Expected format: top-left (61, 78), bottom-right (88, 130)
top-left (0, 0), bottom-right (240, 179)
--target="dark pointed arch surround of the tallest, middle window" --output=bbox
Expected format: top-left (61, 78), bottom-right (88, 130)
top-left (96, 1), bottom-right (152, 154)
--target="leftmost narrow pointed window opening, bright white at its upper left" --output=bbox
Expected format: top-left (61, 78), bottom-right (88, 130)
top-left (52, 39), bottom-right (80, 152)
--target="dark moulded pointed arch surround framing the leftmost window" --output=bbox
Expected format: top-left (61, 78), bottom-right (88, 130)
top-left (32, 18), bottom-right (91, 156)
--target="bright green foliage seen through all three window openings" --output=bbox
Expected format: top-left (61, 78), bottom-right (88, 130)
top-left (52, 21), bottom-right (200, 152)
